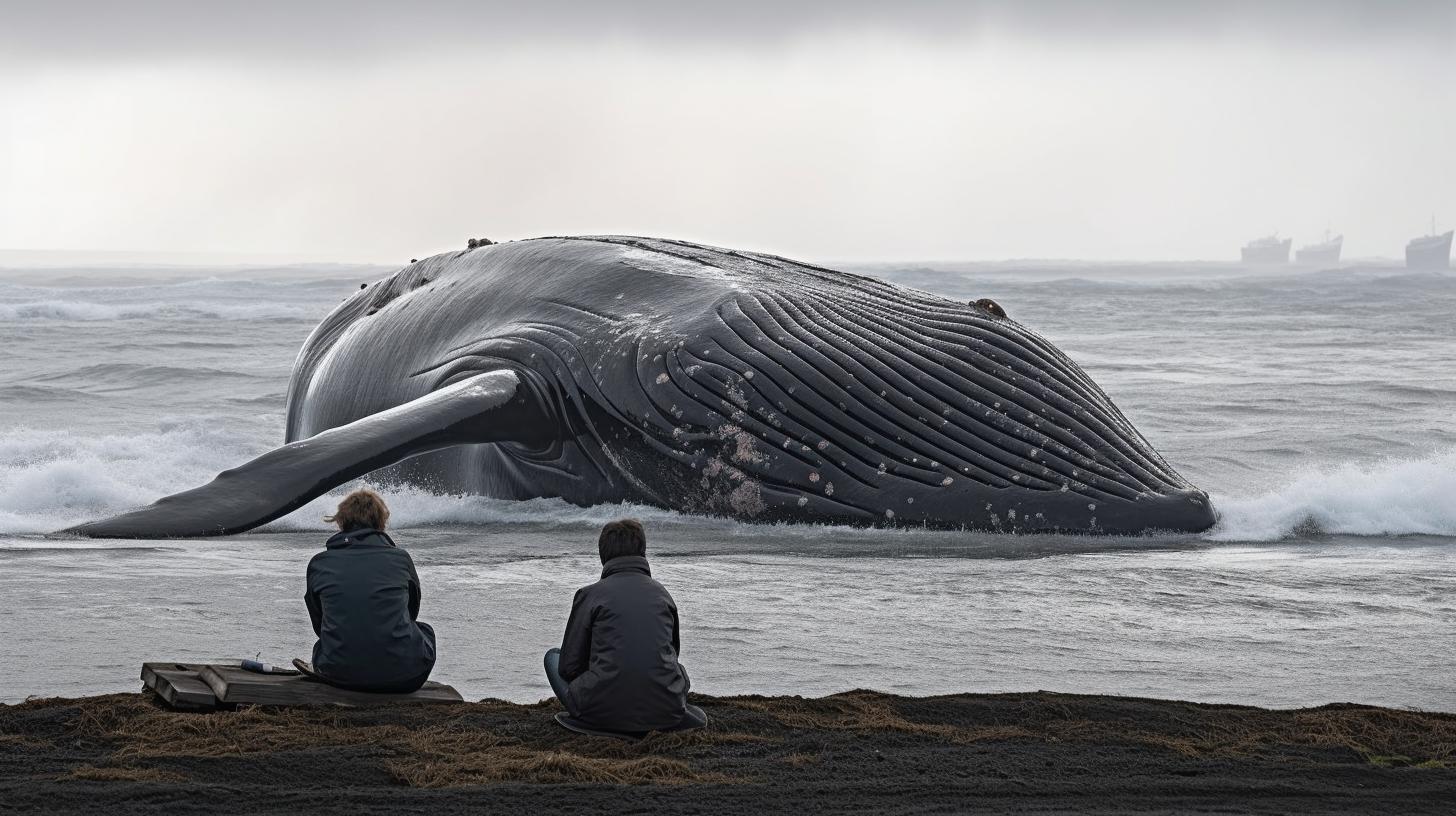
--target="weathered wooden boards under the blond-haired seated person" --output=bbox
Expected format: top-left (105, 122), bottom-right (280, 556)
top-left (141, 663), bottom-right (464, 711)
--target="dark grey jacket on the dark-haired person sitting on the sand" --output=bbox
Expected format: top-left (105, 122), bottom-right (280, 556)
top-left (561, 555), bottom-right (689, 731)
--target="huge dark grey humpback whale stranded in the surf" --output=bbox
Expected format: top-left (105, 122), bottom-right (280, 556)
top-left (70, 236), bottom-right (1214, 538)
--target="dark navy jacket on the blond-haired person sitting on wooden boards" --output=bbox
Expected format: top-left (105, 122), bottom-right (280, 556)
top-left (304, 529), bottom-right (435, 688)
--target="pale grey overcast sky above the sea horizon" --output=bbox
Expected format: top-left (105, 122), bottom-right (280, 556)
top-left (0, 0), bottom-right (1456, 262)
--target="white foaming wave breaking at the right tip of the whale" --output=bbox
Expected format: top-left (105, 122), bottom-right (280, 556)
top-left (1207, 447), bottom-right (1456, 541)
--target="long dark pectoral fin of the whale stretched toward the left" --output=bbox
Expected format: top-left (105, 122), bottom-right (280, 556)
top-left (64, 370), bottom-right (555, 538)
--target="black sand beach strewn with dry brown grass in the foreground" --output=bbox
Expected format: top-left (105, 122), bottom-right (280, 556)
top-left (0, 691), bottom-right (1456, 815)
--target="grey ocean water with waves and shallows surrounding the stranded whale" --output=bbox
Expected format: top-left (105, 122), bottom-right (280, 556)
top-left (0, 262), bottom-right (1456, 711)
